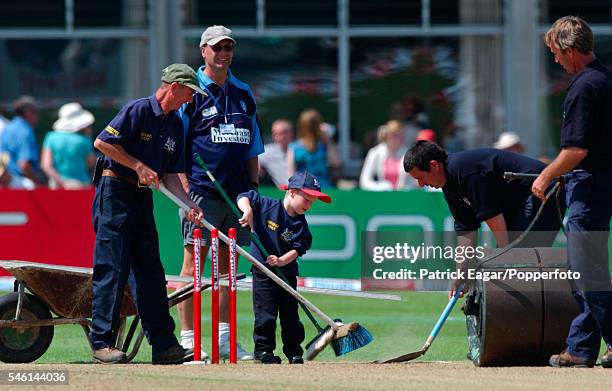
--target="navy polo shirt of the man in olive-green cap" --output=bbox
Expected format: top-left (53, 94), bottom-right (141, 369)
top-left (98, 95), bottom-right (185, 180)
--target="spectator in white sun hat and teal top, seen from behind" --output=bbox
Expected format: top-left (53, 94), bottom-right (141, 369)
top-left (41, 102), bottom-right (96, 189)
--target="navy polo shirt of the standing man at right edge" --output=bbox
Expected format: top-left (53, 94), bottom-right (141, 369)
top-left (561, 59), bottom-right (612, 171)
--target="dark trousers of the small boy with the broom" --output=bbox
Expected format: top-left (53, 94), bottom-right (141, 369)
top-left (251, 268), bottom-right (304, 359)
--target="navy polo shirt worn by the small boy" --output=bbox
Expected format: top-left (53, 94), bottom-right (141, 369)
top-left (237, 190), bottom-right (312, 276)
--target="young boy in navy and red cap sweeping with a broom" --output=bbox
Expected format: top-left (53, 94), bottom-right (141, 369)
top-left (238, 172), bottom-right (331, 364)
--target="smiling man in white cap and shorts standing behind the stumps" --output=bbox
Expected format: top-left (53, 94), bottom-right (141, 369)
top-left (178, 26), bottom-right (264, 360)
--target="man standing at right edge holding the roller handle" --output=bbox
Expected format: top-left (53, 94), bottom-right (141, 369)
top-left (532, 16), bottom-right (612, 368)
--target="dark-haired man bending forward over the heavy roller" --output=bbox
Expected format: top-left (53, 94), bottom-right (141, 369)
top-left (404, 141), bottom-right (565, 294)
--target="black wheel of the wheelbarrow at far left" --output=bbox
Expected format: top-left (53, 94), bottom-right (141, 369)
top-left (0, 293), bottom-right (53, 363)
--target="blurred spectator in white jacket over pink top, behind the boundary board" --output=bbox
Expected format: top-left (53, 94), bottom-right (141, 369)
top-left (359, 120), bottom-right (414, 191)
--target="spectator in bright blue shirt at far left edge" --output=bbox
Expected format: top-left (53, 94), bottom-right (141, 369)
top-left (0, 95), bottom-right (39, 183)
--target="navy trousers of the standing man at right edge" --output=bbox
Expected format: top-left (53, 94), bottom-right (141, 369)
top-left (566, 171), bottom-right (612, 359)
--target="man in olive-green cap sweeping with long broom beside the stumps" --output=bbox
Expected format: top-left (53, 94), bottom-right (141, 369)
top-left (91, 64), bottom-right (202, 364)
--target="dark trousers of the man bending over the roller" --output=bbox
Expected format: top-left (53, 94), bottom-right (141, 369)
top-left (504, 191), bottom-right (566, 247)
